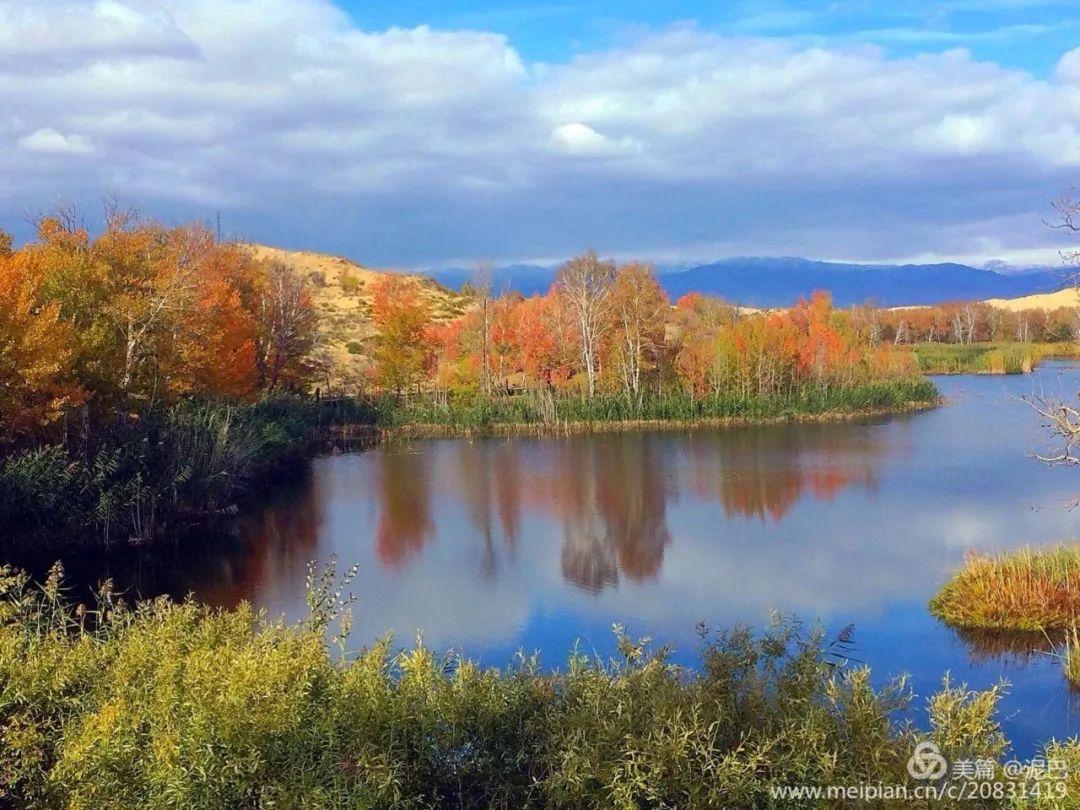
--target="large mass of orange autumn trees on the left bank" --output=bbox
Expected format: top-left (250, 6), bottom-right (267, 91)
top-left (0, 212), bottom-right (315, 434)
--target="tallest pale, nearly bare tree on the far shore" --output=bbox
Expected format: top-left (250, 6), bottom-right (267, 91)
top-left (555, 251), bottom-right (616, 396)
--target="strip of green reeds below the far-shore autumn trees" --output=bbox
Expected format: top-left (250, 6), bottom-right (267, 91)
top-left (376, 378), bottom-right (940, 433)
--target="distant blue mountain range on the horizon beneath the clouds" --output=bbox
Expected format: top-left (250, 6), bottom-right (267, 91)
top-left (429, 258), bottom-right (1066, 307)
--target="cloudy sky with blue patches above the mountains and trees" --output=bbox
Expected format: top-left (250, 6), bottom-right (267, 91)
top-left (0, 0), bottom-right (1080, 269)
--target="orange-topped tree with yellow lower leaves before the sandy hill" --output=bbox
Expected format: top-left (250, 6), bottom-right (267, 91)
top-left (372, 273), bottom-right (431, 394)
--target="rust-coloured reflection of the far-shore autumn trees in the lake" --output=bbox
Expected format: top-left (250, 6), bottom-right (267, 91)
top-left (362, 424), bottom-right (904, 592)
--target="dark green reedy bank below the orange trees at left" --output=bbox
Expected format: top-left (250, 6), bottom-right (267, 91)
top-left (0, 394), bottom-right (372, 546)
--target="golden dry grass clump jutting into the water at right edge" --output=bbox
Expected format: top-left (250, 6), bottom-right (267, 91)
top-left (930, 545), bottom-right (1080, 631)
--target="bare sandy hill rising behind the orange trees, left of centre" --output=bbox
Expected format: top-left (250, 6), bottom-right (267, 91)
top-left (244, 244), bottom-right (464, 388)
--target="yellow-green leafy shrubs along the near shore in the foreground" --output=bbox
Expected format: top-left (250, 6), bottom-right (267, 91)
top-left (0, 570), bottom-right (1019, 809)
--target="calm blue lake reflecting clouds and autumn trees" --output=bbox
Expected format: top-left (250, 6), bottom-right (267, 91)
top-left (29, 363), bottom-right (1080, 754)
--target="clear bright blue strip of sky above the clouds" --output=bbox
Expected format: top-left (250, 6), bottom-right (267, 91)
top-left (340, 0), bottom-right (1080, 73)
